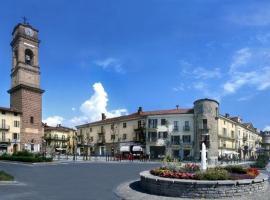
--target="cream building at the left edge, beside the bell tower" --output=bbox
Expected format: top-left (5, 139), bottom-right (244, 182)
top-left (0, 107), bottom-right (21, 154)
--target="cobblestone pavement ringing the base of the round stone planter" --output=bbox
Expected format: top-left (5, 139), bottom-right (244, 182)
top-left (115, 164), bottom-right (270, 200)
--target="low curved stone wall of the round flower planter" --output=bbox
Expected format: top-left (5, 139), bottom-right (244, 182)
top-left (140, 171), bottom-right (268, 198)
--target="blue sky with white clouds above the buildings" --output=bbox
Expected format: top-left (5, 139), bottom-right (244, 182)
top-left (0, 0), bottom-right (270, 129)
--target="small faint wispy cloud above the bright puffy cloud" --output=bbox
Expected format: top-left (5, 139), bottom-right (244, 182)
top-left (95, 57), bottom-right (125, 74)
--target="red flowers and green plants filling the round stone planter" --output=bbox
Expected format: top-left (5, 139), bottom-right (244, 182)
top-left (150, 164), bottom-right (260, 180)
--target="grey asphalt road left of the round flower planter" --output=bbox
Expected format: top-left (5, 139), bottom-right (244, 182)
top-left (0, 162), bottom-right (159, 200)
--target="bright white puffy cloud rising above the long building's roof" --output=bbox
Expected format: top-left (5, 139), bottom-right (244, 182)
top-left (70, 82), bottom-right (128, 125)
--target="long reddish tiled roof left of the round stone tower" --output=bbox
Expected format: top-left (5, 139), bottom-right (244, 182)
top-left (76, 109), bottom-right (194, 127)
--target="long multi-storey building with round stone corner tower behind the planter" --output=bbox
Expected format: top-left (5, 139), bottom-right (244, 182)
top-left (77, 99), bottom-right (262, 164)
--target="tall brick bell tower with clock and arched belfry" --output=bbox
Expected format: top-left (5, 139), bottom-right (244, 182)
top-left (8, 21), bottom-right (44, 152)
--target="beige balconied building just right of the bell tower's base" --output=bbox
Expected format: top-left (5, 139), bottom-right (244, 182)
top-left (43, 124), bottom-right (76, 155)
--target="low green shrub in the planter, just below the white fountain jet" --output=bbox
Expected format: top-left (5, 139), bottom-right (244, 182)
top-left (195, 168), bottom-right (229, 180)
